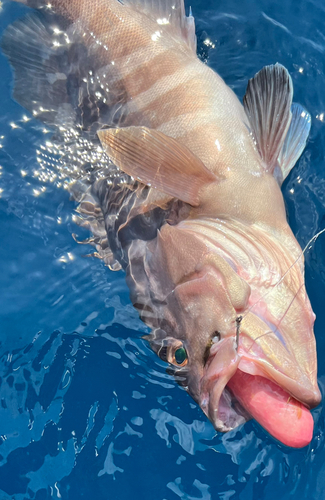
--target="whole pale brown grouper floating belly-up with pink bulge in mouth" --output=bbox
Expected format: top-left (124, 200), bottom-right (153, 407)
top-left (2, 0), bottom-right (321, 447)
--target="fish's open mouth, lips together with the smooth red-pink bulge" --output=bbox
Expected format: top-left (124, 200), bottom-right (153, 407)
top-left (201, 338), bottom-right (321, 448)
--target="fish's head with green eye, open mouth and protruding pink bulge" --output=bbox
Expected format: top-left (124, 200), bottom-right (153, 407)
top-left (141, 223), bottom-right (320, 446)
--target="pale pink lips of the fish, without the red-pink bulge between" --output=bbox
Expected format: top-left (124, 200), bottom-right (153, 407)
top-left (200, 337), bottom-right (321, 432)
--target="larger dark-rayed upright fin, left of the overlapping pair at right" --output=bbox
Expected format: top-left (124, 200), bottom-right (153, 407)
top-left (244, 63), bottom-right (293, 173)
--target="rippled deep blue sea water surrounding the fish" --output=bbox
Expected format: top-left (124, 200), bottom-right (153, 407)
top-left (0, 0), bottom-right (325, 500)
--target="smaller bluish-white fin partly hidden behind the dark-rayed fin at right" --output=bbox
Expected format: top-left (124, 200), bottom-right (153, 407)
top-left (278, 103), bottom-right (311, 181)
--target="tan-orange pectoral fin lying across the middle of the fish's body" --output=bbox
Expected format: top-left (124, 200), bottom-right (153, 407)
top-left (98, 127), bottom-right (217, 206)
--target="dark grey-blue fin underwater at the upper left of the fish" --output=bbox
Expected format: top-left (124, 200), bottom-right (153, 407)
top-left (1, 13), bottom-right (126, 133)
